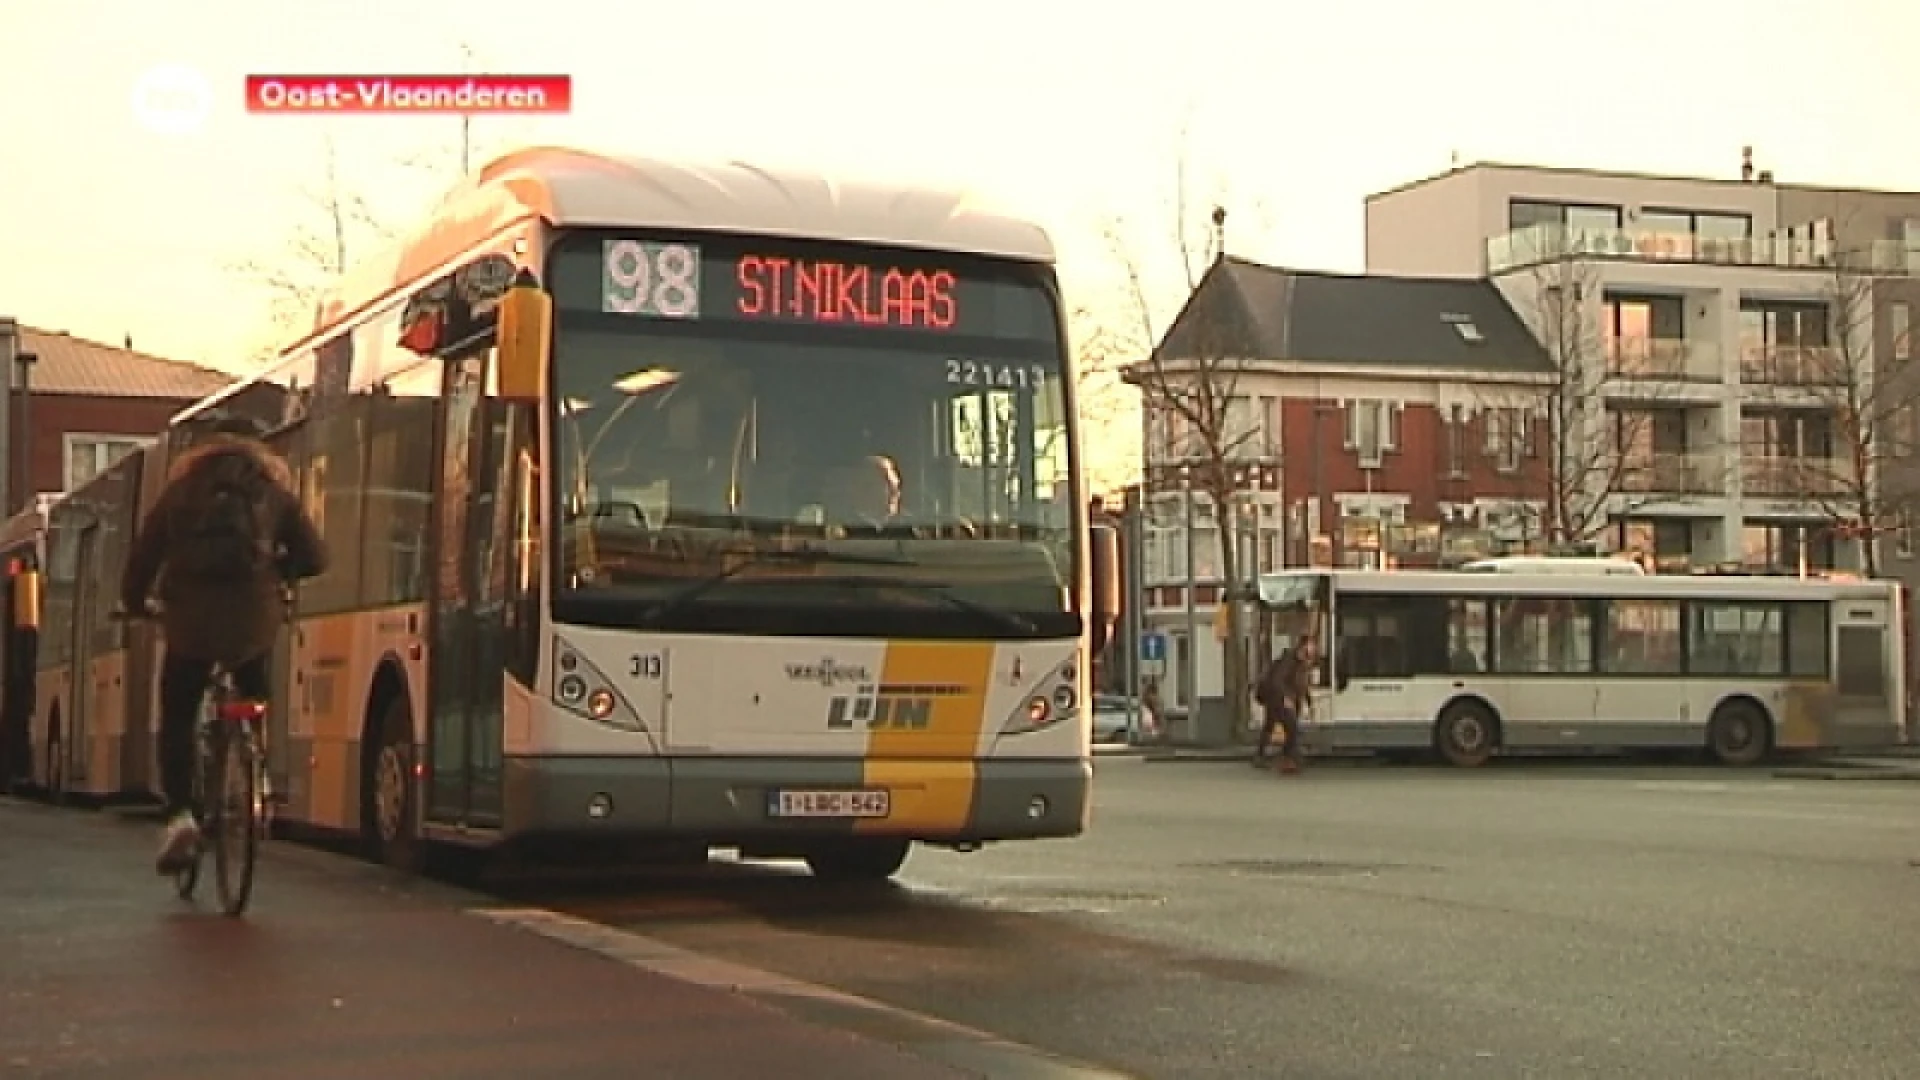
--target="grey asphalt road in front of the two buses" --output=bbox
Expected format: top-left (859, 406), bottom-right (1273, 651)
top-left (510, 759), bottom-right (1920, 1080)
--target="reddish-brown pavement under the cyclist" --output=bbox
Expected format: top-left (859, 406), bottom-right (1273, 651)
top-left (0, 798), bottom-right (1082, 1080)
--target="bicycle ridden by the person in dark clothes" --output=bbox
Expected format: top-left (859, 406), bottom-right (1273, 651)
top-left (115, 611), bottom-right (273, 917)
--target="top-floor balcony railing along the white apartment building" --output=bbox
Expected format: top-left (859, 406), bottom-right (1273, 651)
top-left (1486, 225), bottom-right (1920, 275)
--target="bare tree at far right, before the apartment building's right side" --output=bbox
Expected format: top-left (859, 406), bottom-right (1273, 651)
top-left (1751, 254), bottom-right (1920, 577)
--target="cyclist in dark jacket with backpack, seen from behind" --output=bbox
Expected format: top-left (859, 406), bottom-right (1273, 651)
top-left (121, 411), bottom-right (326, 874)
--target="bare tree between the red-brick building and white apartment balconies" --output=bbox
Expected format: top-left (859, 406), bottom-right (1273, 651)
top-left (1482, 256), bottom-right (1724, 550)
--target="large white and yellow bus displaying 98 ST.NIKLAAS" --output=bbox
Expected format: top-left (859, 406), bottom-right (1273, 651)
top-left (71, 148), bottom-right (1117, 878)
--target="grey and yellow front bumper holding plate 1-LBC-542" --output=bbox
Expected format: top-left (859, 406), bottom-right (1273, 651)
top-left (503, 757), bottom-right (1092, 846)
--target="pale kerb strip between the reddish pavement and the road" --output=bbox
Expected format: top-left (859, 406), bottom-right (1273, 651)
top-left (480, 907), bottom-right (1131, 1080)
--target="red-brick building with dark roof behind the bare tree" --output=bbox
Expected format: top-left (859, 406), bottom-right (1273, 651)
top-left (1125, 258), bottom-right (1551, 711)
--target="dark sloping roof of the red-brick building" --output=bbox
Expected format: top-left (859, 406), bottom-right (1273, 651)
top-left (1158, 256), bottom-right (1553, 373)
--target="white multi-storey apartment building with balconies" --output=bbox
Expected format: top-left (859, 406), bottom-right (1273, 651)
top-left (1365, 161), bottom-right (1920, 569)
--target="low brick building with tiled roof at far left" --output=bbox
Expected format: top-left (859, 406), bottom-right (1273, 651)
top-left (6, 327), bottom-right (232, 507)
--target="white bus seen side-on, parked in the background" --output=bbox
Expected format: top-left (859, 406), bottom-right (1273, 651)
top-left (1258, 571), bottom-right (1907, 767)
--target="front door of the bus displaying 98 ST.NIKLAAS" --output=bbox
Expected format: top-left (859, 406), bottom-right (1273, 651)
top-left (426, 354), bottom-right (513, 828)
